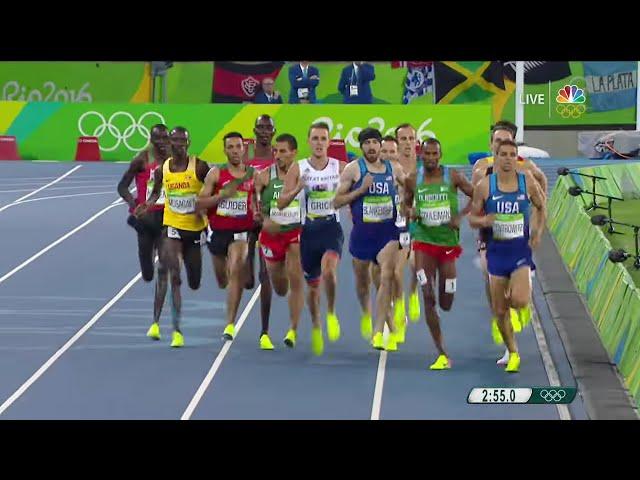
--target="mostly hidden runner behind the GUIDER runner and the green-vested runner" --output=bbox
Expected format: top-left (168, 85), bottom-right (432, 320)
top-left (245, 114), bottom-right (276, 348)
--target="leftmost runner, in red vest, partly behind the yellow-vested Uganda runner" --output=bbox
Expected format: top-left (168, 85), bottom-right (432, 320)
top-left (118, 124), bottom-right (170, 332)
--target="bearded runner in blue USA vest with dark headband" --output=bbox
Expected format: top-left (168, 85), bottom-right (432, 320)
top-left (334, 128), bottom-right (404, 351)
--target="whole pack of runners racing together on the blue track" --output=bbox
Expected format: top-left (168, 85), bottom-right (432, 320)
top-left (118, 115), bottom-right (547, 372)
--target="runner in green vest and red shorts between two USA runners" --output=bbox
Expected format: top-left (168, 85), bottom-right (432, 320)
top-left (405, 138), bottom-right (473, 370)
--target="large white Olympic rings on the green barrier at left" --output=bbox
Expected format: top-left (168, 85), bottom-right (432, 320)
top-left (78, 111), bottom-right (166, 152)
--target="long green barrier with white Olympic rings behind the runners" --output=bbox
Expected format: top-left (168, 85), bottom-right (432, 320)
top-left (0, 102), bottom-right (491, 164)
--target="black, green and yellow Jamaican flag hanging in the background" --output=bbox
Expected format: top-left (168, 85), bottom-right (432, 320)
top-left (433, 61), bottom-right (515, 120)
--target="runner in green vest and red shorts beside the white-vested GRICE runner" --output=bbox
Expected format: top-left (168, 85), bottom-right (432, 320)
top-left (255, 133), bottom-right (304, 350)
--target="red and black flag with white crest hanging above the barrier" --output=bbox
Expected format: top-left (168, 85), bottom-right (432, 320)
top-left (212, 62), bottom-right (285, 103)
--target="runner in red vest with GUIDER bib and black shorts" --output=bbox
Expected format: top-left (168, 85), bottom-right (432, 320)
top-left (196, 132), bottom-right (257, 340)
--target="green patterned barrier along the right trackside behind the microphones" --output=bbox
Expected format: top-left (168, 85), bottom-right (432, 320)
top-left (547, 164), bottom-right (640, 404)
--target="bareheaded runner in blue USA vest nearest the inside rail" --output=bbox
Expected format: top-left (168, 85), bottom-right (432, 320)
top-left (469, 140), bottom-right (546, 372)
